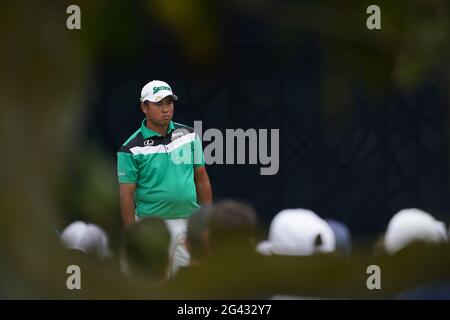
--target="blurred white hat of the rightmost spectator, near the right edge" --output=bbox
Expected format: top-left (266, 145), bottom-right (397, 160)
top-left (384, 209), bottom-right (447, 254)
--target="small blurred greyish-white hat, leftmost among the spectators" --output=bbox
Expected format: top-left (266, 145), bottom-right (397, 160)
top-left (61, 221), bottom-right (109, 258)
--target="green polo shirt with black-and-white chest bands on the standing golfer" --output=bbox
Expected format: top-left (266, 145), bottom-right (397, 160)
top-left (117, 119), bottom-right (205, 219)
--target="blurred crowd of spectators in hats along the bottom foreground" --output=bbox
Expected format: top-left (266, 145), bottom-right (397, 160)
top-left (60, 200), bottom-right (450, 299)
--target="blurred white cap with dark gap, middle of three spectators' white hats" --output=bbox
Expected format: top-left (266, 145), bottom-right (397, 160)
top-left (256, 209), bottom-right (336, 256)
